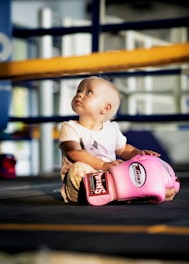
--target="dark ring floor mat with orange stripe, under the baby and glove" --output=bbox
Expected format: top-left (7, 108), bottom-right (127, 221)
top-left (0, 176), bottom-right (189, 260)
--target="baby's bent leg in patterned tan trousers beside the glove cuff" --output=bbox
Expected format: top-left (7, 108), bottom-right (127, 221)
top-left (61, 162), bottom-right (96, 202)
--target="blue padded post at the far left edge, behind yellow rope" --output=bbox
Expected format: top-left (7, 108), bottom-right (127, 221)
top-left (0, 0), bottom-right (12, 131)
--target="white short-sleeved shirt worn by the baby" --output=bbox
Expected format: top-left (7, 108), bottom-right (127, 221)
top-left (59, 120), bottom-right (127, 162)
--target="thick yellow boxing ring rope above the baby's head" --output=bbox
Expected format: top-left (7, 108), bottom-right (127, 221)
top-left (0, 42), bottom-right (189, 81)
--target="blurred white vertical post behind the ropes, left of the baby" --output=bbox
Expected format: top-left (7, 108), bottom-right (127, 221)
top-left (38, 8), bottom-right (53, 173)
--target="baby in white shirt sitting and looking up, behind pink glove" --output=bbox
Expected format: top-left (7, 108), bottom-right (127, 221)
top-left (59, 76), bottom-right (176, 202)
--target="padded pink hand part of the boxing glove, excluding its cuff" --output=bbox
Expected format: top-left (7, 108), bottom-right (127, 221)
top-left (111, 155), bottom-right (180, 203)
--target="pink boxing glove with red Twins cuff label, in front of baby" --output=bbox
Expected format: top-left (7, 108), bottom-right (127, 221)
top-left (84, 155), bottom-right (180, 206)
